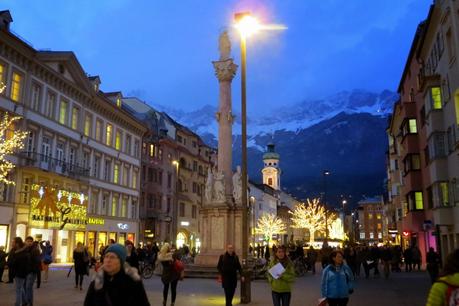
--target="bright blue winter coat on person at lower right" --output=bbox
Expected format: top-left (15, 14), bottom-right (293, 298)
top-left (321, 264), bottom-right (354, 298)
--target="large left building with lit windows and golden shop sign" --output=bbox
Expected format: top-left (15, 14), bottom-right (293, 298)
top-left (0, 12), bottom-right (144, 262)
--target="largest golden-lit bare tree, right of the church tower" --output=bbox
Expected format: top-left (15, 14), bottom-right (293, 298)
top-left (290, 199), bottom-right (326, 243)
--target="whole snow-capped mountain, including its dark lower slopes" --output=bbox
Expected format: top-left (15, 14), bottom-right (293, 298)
top-left (154, 90), bottom-right (398, 204)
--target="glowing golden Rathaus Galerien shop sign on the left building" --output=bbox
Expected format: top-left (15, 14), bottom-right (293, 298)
top-left (29, 184), bottom-right (88, 230)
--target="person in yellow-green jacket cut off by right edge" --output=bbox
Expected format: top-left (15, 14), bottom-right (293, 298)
top-left (426, 249), bottom-right (459, 306)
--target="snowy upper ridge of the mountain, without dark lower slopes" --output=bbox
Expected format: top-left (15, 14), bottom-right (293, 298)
top-left (154, 90), bottom-right (398, 146)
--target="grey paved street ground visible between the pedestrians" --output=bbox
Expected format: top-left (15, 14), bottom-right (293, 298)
top-left (0, 270), bottom-right (430, 306)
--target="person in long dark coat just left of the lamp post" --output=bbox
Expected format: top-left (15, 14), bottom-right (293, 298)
top-left (217, 244), bottom-right (244, 306)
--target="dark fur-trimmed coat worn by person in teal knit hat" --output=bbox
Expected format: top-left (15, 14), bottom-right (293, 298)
top-left (84, 264), bottom-right (150, 306)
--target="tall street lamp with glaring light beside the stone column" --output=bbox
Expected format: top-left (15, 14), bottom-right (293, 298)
top-left (234, 12), bottom-right (260, 304)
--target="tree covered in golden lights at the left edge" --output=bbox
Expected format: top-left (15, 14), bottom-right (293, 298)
top-left (0, 113), bottom-right (28, 185)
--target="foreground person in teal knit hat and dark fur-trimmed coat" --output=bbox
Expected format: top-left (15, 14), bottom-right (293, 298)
top-left (84, 243), bottom-right (150, 306)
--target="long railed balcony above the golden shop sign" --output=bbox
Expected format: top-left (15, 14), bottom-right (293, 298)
top-left (18, 151), bottom-right (89, 179)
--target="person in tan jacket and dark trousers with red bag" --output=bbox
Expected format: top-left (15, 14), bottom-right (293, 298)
top-left (158, 243), bottom-right (180, 306)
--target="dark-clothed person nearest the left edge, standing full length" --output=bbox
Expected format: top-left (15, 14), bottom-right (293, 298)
top-left (9, 237), bottom-right (30, 306)
